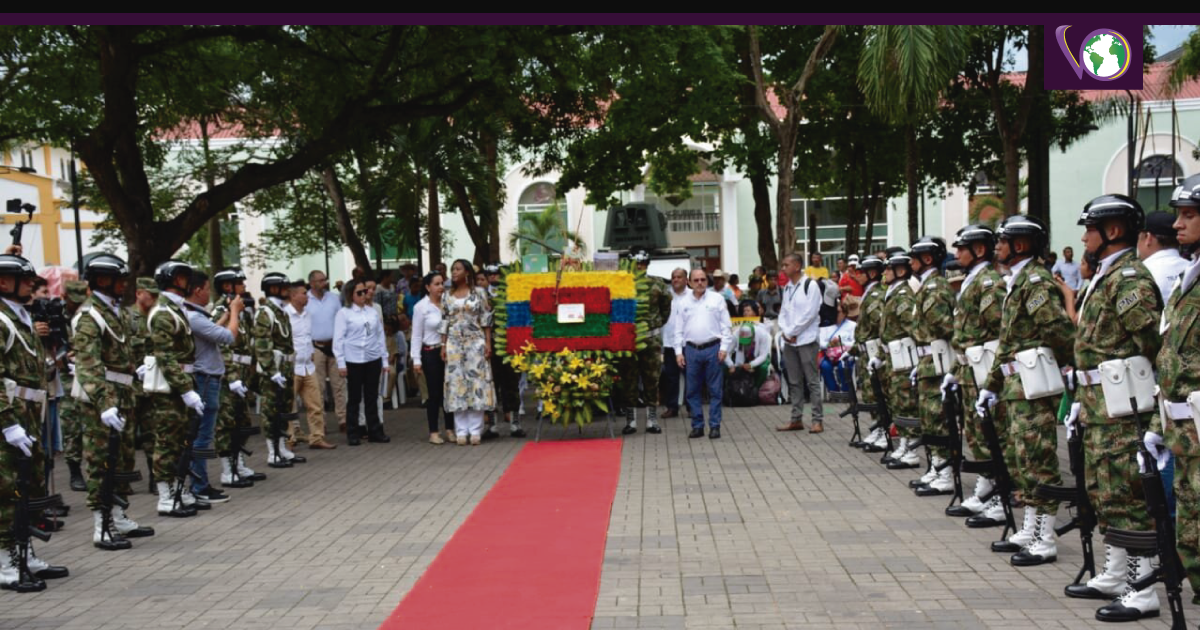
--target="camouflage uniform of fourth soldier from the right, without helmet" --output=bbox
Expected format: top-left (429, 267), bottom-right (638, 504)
top-left (950, 265), bottom-right (1013, 466)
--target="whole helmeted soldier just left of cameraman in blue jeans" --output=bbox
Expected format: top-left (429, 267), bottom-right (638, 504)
top-left (144, 260), bottom-right (210, 518)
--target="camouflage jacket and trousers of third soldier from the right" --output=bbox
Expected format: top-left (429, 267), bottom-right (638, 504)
top-left (985, 258), bottom-right (1074, 514)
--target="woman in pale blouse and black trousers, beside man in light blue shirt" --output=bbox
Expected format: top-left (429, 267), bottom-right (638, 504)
top-left (334, 280), bottom-right (391, 446)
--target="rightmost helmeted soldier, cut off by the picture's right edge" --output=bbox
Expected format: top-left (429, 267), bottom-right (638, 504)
top-left (1145, 175), bottom-right (1200, 605)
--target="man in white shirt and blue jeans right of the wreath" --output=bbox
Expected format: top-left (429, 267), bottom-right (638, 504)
top-left (671, 269), bottom-right (733, 439)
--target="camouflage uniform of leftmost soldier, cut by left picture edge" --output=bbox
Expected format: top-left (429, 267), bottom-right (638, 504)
top-left (0, 300), bottom-right (46, 550)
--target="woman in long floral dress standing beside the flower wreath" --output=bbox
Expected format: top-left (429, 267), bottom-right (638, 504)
top-left (439, 259), bottom-right (496, 444)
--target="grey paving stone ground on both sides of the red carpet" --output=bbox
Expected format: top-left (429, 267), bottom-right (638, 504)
top-left (0, 407), bottom-right (1200, 630)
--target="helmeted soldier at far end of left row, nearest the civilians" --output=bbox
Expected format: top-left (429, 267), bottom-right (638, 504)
top-left (251, 271), bottom-right (306, 468)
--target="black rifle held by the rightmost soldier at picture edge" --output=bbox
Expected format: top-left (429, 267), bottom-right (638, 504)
top-left (1104, 398), bottom-right (1187, 630)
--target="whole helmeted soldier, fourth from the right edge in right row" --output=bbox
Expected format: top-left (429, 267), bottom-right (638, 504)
top-left (942, 224), bottom-right (1008, 527)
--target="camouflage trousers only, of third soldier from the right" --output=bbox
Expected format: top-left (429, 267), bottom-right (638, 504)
top-left (992, 396), bottom-right (1062, 514)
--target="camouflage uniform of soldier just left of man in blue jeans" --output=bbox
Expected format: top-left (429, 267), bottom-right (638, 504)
top-left (148, 292), bottom-right (196, 482)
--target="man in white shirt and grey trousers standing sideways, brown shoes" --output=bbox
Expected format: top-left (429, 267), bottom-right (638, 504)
top-left (776, 252), bottom-right (824, 433)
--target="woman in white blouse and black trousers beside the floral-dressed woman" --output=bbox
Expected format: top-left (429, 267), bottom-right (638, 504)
top-left (408, 271), bottom-right (457, 444)
